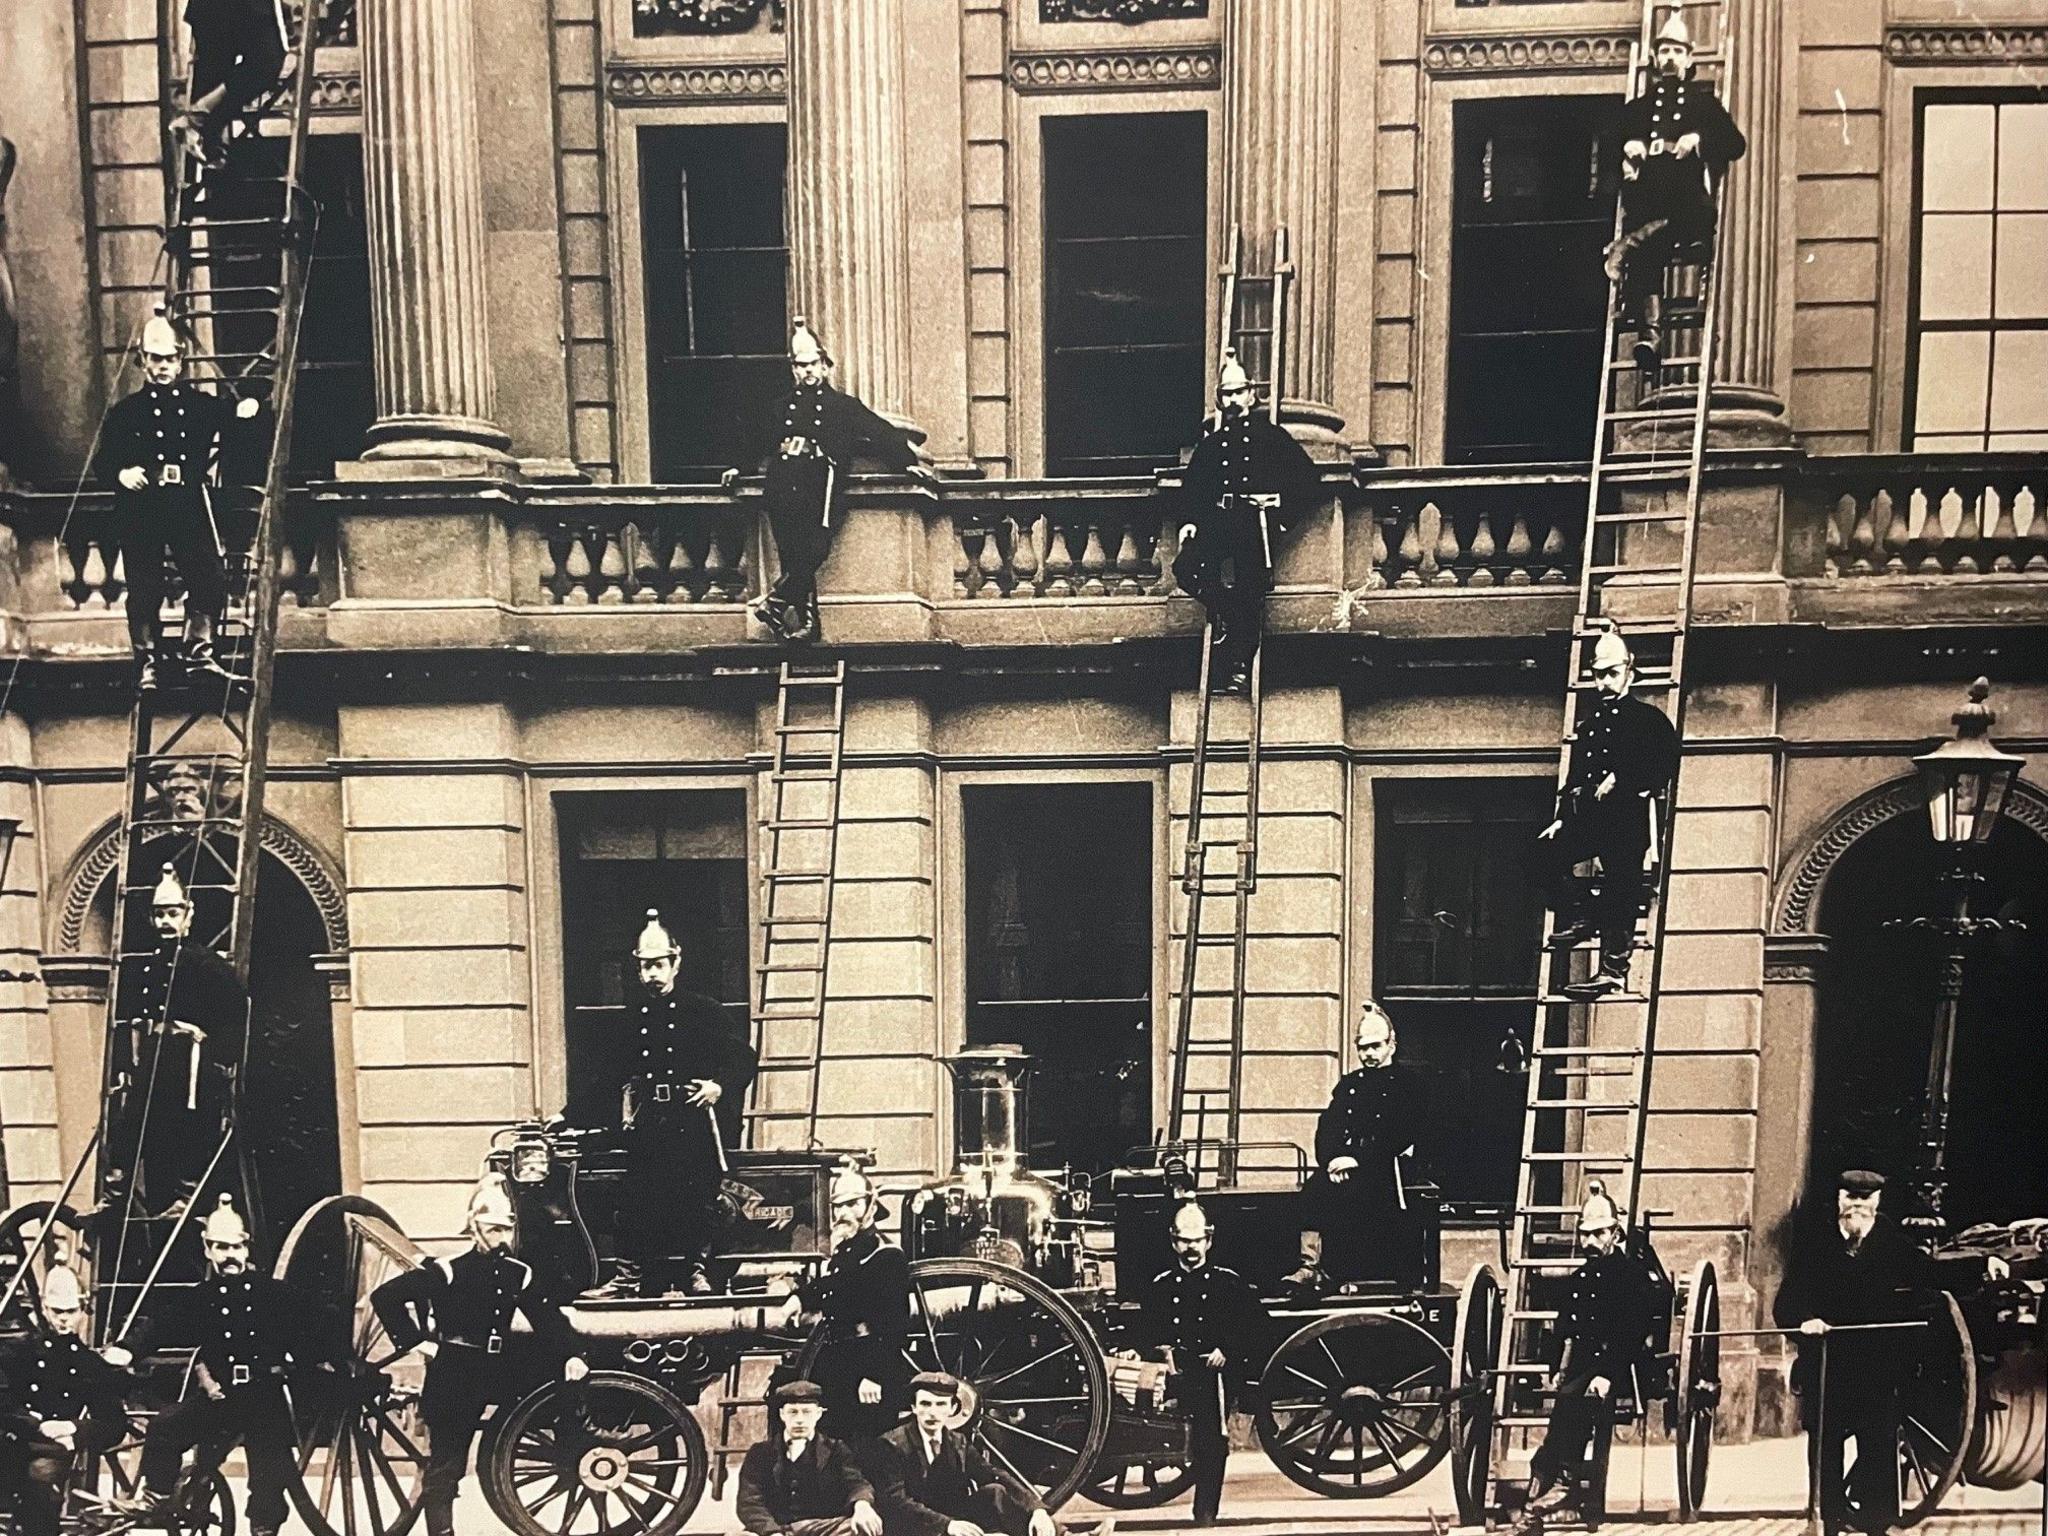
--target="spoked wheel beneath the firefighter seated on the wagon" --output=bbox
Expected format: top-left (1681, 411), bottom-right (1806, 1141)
top-left (1253, 1313), bottom-right (1450, 1499)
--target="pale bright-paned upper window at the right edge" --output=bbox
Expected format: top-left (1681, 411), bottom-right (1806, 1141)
top-left (1907, 94), bottom-right (2048, 453)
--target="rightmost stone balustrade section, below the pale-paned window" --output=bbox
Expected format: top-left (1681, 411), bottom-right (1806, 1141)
top-left (1810, 453), bottom-right (2048, 582)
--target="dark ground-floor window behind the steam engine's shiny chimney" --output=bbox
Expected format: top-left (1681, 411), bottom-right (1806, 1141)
top-left (965, 784), bottom-right (1153, 1171)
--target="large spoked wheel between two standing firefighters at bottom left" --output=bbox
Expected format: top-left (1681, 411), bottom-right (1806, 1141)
top-left (276, 1194), bottom-right (426, 1536)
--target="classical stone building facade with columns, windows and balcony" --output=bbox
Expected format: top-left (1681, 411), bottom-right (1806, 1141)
top-left (0, 0), bottom-right (2048, 1421)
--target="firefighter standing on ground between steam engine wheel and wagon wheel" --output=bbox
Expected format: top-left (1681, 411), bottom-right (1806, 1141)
top-left (1139, 1200), bottom-right (1268, 1526)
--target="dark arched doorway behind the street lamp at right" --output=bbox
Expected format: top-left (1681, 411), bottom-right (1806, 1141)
top-left (1812, 793), bottom-right (2048, 1229)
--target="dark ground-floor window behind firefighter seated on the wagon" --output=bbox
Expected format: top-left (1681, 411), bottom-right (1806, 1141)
top-left (1372, 778), bottom-right (1550, 1204)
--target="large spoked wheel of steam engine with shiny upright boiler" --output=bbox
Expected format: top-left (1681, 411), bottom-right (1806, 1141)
top-left (905, 1260), bottom-right (1110, 1509)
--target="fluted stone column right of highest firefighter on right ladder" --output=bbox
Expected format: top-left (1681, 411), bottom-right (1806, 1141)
top-left (1712, 0), bottom-right (1790, 444)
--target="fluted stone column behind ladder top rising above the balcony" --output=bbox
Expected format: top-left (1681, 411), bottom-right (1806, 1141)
top-left (1223, 0), bottom-right (1343, 438)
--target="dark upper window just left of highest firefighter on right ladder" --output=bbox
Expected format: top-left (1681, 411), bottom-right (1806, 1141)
top-left (1444, 96), bottom-right (1620, 463)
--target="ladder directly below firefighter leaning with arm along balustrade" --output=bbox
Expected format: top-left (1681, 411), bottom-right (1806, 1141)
top-left (748, 662), bottom-right (846, 1149)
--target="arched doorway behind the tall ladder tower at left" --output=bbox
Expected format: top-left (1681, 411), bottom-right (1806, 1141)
top-left (61, 823), bottom-right (346, 1241)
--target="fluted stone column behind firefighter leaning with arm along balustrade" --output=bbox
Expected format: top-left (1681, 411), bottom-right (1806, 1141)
top-left (788, 0), bottom-right (909, 422)
